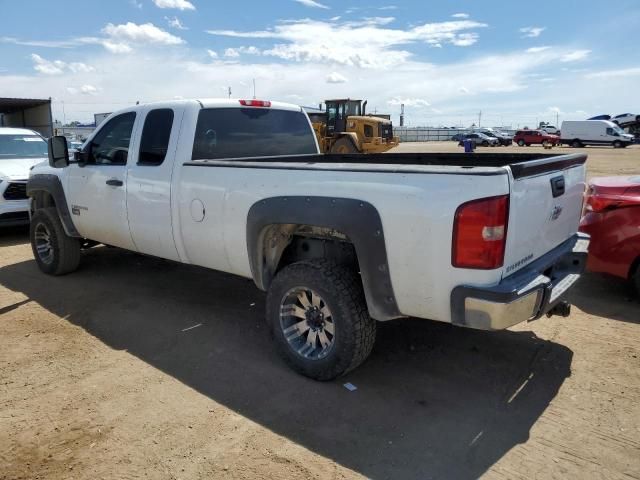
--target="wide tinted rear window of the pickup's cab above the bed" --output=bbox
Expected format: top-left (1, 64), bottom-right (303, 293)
top-left (191, 107), bottom-right (318, 160)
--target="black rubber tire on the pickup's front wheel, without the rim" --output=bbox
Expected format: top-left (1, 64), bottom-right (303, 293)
top-left (29, 207), bottom-right (80, 275)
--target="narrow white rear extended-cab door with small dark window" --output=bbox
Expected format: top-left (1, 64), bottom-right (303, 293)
top-left (127, 107), bottom-right (184, 260)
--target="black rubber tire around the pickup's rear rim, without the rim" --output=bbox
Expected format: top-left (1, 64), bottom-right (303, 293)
top-left (266, 259), bottom-right (376, 381)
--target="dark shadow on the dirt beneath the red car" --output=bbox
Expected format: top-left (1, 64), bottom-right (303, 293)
top-left (569, 273), bottom-right (640, 323)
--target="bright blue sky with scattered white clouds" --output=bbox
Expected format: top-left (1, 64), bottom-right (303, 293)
top-left (0, 0), bottom-right (640, 128)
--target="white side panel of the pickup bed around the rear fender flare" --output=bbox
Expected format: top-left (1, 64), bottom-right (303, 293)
top-left (176, 164), bottom-right (509, 321)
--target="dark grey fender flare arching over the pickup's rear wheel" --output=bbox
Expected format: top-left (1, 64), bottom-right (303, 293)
top-left (247, 196), bottom-right (403, 320)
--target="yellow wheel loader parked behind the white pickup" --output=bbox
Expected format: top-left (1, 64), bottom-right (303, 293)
top-left (309, 98), bottom-right (399, 153)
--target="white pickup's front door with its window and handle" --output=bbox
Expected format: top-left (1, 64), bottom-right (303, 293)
top-left (67, 112), bottom-right (136, 250)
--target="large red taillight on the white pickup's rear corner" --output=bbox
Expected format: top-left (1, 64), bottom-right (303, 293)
top-left (451, 195), bottom-right (509, 270)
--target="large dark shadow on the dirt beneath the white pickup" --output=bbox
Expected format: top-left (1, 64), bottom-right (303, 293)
top-left (0, 248), bottom-right (572, 479)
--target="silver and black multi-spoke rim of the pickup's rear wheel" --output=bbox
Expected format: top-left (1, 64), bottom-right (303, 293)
top-left (280, 287), bottom-right (335, 360)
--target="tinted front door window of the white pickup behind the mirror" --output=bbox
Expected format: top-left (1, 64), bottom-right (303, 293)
top-left (87, 112), bottom-right (136, 165)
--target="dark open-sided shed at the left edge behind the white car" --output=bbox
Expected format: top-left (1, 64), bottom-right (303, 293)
top-left (0, 97), bottom-right (53, 137)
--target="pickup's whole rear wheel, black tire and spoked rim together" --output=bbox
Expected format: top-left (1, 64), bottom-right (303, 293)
top-left (267, 259), bottom-right (376, 381)
